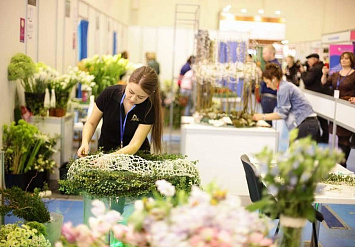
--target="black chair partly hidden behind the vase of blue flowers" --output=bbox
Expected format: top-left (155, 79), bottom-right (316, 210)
top-left (240, 154), bottom-right (324, 246)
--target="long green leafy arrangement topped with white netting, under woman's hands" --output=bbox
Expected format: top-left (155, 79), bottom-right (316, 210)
top-left (59, 153), bottom-right (200, 199)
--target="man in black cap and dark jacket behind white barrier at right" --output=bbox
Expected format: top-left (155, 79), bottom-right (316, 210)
top-left (300, 53), bottom-right (332, 143)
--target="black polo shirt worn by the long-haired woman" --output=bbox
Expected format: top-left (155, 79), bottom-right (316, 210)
top-left (96, 85), bottom-right (154, 152)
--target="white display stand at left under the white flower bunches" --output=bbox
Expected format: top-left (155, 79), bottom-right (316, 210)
top-left (30, 114), bottom-right (74, 180)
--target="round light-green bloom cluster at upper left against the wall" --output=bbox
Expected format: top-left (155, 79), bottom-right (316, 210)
top-left (8, 53), bottom-right (36, 81)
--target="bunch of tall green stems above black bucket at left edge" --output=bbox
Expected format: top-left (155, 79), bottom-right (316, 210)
top-left (2, 119), bottom-right (58, 174)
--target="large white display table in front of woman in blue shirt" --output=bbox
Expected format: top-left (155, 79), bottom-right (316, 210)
top-left (180, 124), bottom-right (279, 196)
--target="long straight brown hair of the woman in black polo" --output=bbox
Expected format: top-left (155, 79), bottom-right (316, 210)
top-left (129, 66), bottom-right (163, 153)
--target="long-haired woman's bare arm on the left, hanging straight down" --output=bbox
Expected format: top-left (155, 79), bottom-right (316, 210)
top-left (77, 104), bottom-right (103, 157)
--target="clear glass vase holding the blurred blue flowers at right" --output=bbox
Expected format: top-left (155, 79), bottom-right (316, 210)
top-left (278, 215), bottom-right (307, 247)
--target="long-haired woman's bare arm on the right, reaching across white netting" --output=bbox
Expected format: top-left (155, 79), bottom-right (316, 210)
top-left (111, 124), bottom-right (152, 154)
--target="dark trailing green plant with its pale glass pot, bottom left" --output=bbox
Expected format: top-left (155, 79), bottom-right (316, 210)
top-left (0, 187), bottom-right (63, 243)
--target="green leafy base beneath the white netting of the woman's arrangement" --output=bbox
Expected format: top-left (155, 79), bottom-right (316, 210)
top-left (59, 153), bottom-right (200, 198)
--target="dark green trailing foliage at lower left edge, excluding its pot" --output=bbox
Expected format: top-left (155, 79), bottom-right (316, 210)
top-left (0, 187), bottom-right (50, 223)
